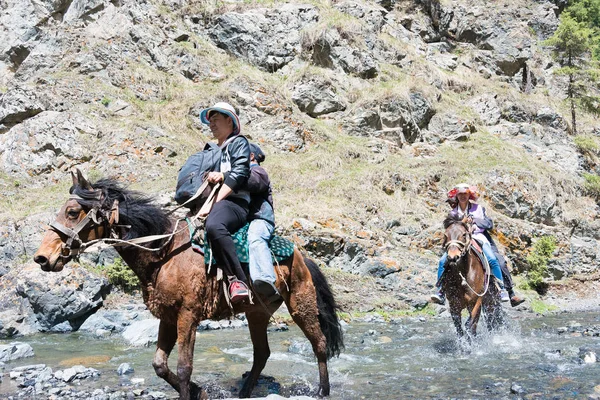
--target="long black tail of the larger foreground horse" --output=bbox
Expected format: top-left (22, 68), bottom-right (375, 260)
top-left (304, 257), bottom-right (344, 359)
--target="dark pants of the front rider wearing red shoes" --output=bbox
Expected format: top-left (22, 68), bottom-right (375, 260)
top-left (205, 199), bottom-right (248, 282)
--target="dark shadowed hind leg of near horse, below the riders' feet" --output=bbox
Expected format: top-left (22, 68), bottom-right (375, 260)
top-left (239, 309), bottom-right (271, 398)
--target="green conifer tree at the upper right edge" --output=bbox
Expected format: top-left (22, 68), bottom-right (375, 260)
top-left (546, 12), bottom-right (600, 134)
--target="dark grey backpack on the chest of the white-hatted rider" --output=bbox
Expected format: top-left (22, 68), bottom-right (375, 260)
top-left (175, 143), bottom-right (221, 208)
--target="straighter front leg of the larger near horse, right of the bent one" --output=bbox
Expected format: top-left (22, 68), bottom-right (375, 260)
top-left (177, 312), bottom-right (205, 400)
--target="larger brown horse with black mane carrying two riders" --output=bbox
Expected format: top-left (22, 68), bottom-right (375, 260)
top-left (34, 171), bottom-right (343, 400)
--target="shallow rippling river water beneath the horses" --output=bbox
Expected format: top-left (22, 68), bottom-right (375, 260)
top-left (0, 312), bottom-right (600, 399)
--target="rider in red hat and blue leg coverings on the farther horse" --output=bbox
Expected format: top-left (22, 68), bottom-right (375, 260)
top-left (431, 183), bottom-right (525, 307)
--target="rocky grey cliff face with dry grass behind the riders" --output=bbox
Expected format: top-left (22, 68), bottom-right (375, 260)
top-left (0, 0), bottom-right (600, 334)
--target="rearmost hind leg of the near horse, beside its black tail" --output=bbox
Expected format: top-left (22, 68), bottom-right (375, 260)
top-left (287, 283), bottom-right (330, 397)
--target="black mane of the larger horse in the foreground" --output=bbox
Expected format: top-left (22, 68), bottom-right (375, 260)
top-left (69, 178), bottom-right (171, 240)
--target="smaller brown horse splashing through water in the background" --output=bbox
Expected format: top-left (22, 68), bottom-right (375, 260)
top-left (442, 216), bottom-right (502, 339)
